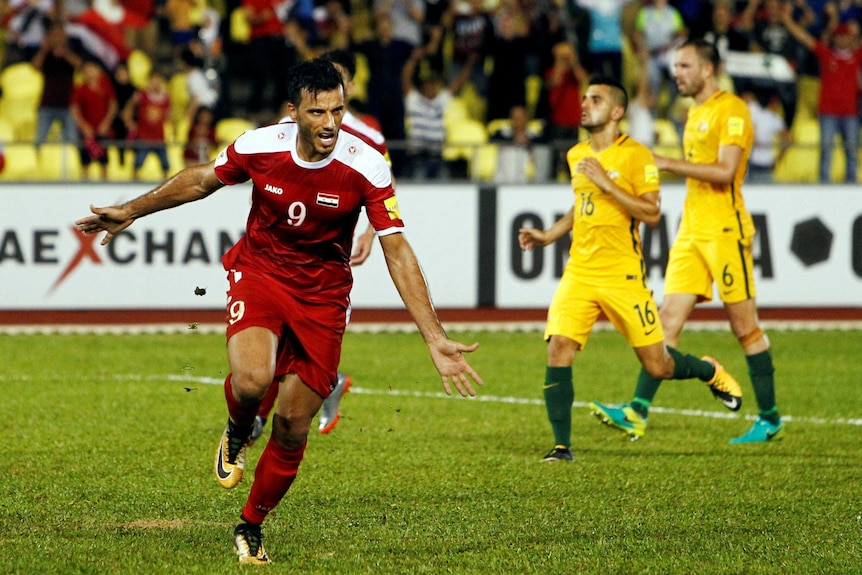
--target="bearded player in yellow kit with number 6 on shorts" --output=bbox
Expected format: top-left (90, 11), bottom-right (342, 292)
top-left (649, 40), bottom-right (784, 443)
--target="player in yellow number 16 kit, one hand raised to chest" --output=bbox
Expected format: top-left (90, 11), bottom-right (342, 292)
top-left (518, 78), bottom-right (741, 461)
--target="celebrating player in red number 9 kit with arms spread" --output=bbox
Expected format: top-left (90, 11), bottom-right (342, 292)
top-left (76, 60), bottom-right (482, 563)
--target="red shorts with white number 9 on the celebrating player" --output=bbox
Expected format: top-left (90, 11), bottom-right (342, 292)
top-left (227, 270), bottom-right (350, 398)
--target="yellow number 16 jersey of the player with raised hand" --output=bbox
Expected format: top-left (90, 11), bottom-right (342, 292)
top-left (566, 134), bottom-right (659, 287)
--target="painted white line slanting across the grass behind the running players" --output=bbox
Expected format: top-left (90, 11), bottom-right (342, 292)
top-left (159, 375), bottom-right (862, 427)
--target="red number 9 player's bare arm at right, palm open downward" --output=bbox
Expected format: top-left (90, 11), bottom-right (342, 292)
top-left (380, 233), bottom-right (482, 397)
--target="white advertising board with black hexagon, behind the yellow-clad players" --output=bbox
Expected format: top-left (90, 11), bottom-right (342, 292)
top-left (495, 184), bottom-right (862, 308)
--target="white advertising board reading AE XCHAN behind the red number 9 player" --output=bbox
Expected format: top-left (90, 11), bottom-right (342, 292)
top-left (0, 184), bottom-right (478, 310)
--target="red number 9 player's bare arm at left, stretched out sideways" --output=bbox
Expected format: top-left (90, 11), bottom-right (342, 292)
top-left (75, 162), bottom-right (223, 245)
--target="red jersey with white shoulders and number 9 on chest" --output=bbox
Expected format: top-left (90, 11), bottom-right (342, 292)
top-left (215, 123), bottom-right (404, 297)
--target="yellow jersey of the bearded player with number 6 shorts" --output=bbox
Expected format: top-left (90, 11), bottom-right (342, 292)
top-left (680, 91), bottom-right (754, 239)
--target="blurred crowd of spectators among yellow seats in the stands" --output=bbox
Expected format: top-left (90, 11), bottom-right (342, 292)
top-left (0, 0), bottom-right (862, 183)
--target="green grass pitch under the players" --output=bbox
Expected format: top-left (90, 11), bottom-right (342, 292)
top-left (0, 330), bottom-right (862, 575)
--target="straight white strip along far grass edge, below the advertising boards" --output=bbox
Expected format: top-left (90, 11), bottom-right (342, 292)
top-left (5, 320), bottom-right (862, 335)
